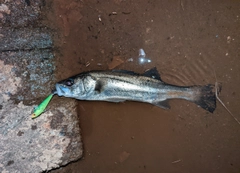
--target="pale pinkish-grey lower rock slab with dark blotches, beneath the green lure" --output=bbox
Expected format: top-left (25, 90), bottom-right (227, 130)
top-left (0, 99), bottom-right (82, 173)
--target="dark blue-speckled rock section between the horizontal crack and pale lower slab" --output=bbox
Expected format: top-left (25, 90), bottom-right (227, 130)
top-left (0, 49), bottom-right (55, 104)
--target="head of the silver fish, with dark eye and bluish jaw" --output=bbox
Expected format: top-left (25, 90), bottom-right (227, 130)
top-left (55, 77), bottom-right (86, 98)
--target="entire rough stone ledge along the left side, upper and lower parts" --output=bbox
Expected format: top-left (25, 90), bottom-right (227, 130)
top-left (0, 0), bottom-right (82, 173)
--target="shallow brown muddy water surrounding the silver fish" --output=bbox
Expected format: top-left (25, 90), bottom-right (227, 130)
top-left (45, 0), bottom-right (240, 173)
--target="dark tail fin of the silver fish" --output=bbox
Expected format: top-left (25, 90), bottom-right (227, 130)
top-left (193, 85), bottom-right (216, 113)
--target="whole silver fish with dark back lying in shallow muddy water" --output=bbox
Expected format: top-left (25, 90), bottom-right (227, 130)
top-left (55, 67), bottom-right (216, 113)
